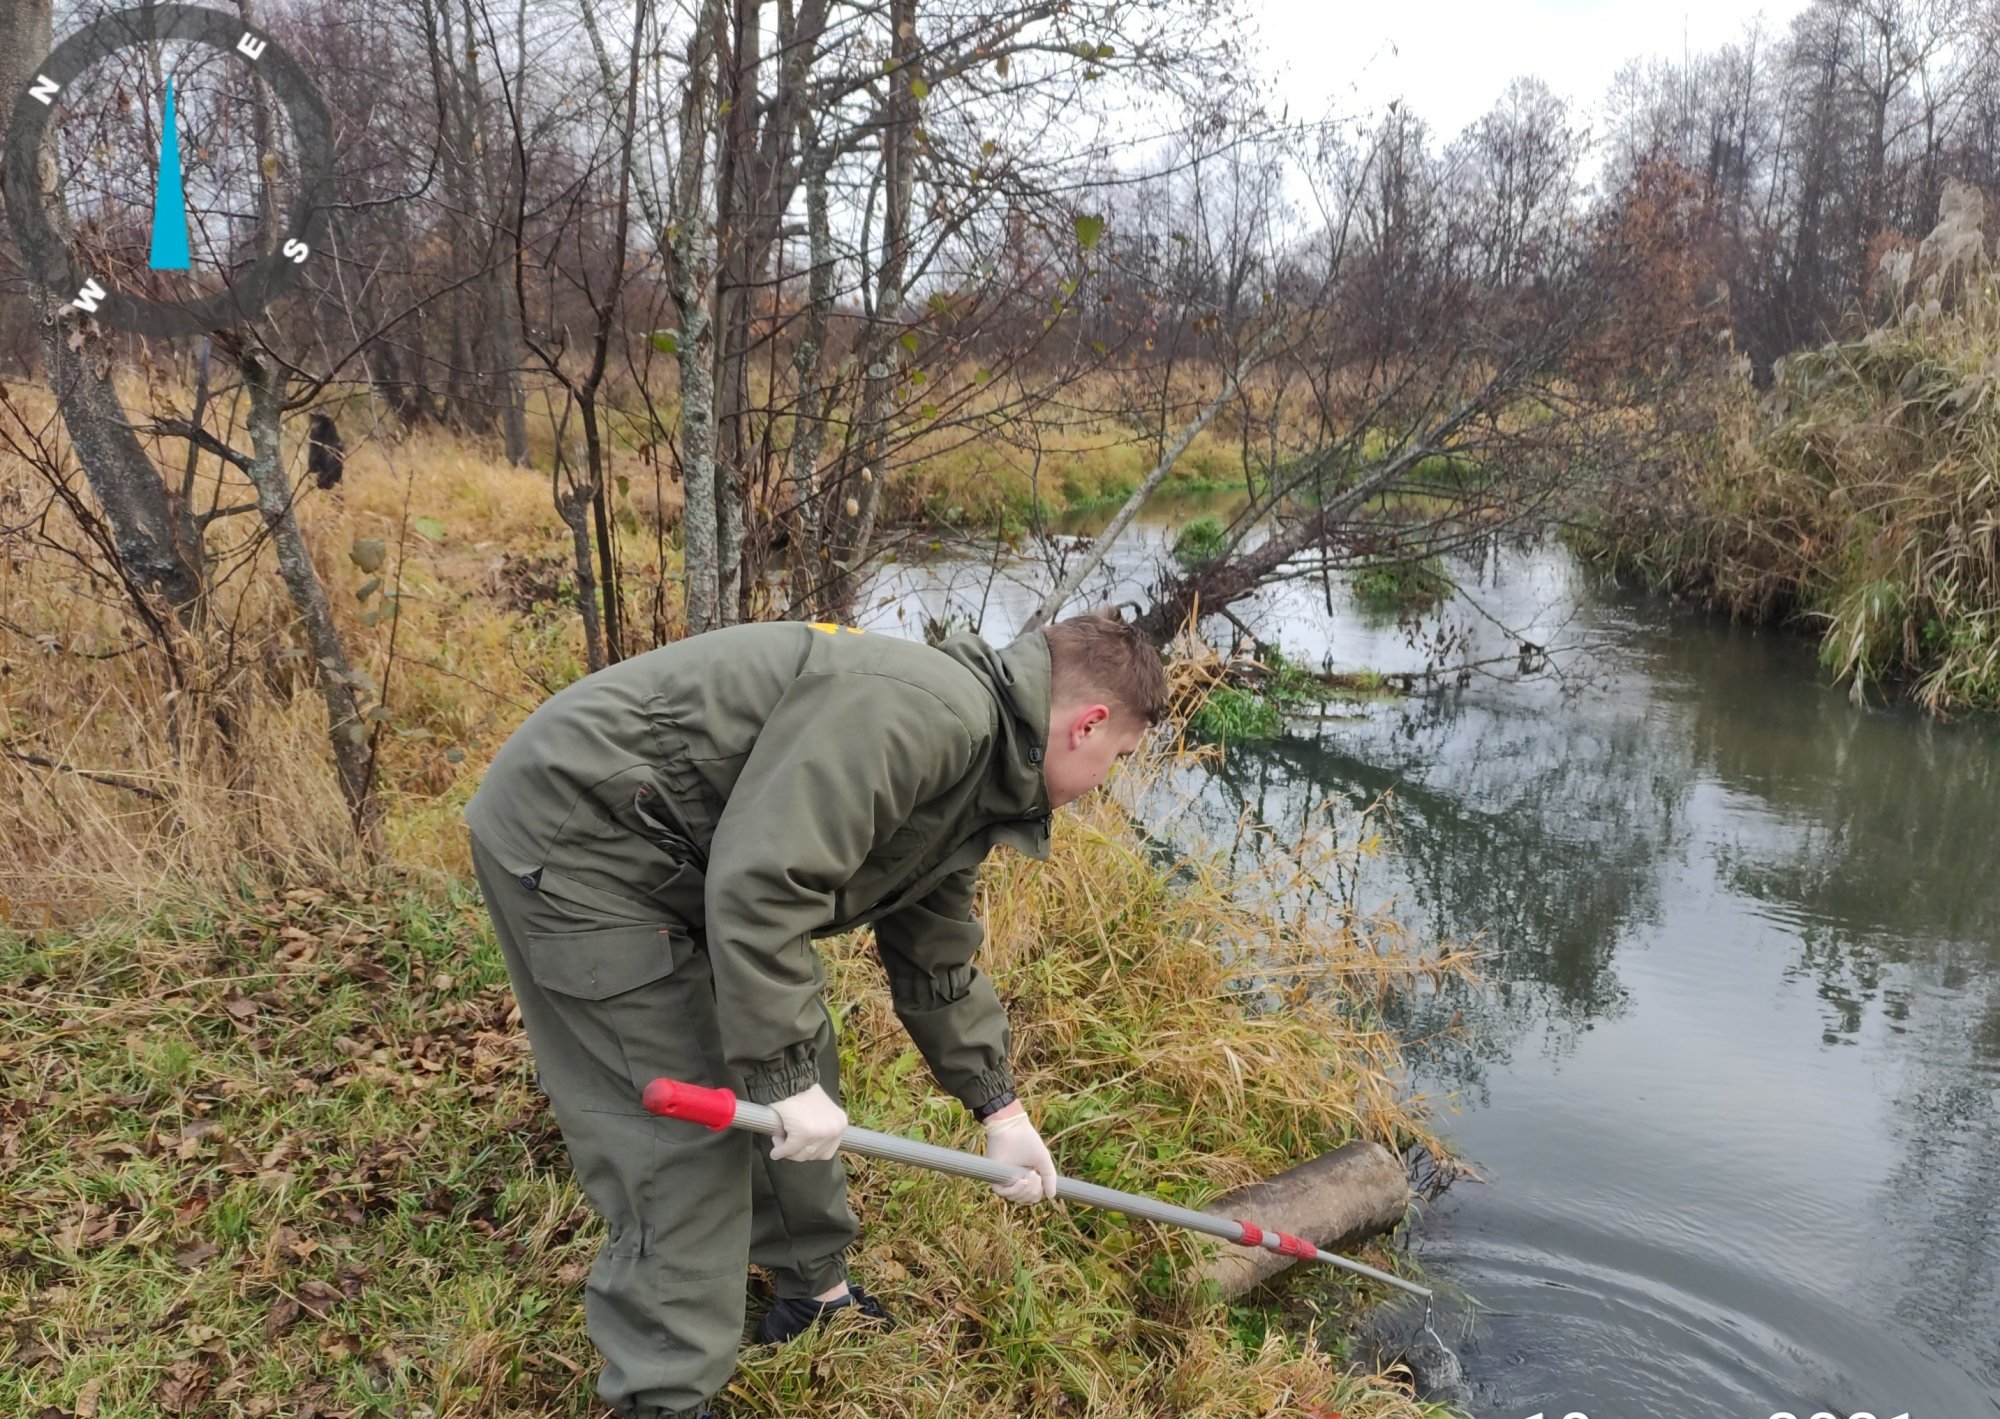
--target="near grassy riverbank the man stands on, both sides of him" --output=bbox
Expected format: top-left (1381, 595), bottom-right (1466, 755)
top-left (0, 779), bottom-right (1456, 1419)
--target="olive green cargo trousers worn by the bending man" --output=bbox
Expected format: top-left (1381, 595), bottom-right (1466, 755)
top-left (472, 837), bottom-right (856, 1419)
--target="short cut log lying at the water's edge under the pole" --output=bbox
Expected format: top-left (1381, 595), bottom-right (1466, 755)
top-left (1200, 1143), bottom-right (1410, 1299)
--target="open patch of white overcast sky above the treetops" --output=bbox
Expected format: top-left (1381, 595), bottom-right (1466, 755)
top-left (1244, 0), bottom-right (1806, 158)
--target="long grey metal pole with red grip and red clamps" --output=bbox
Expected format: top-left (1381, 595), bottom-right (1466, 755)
top-left (646, 1079), bottom-right (1430, 1301)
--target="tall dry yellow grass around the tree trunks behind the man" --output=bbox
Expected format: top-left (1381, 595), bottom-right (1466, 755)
top-left (0, 375), bottom-right (616, 921)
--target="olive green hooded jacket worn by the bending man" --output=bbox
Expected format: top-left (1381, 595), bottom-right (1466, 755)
top-left (466, 622), bottom-right (1050, 1107)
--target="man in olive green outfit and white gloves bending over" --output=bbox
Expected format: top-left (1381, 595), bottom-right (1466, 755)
top-left (466, 614), bottom-right (1166, 1419)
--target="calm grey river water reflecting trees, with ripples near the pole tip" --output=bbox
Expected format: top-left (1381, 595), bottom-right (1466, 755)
top-left (860, 508), bottom-right (2000, 1419)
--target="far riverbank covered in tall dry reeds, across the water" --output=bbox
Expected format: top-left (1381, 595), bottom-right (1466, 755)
top-left (1574, 218), bottom-right (2000, 715)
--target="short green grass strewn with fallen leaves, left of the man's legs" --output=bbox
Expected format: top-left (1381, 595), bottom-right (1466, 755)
top-left (0, 889), bottom-right (572, 1419)
